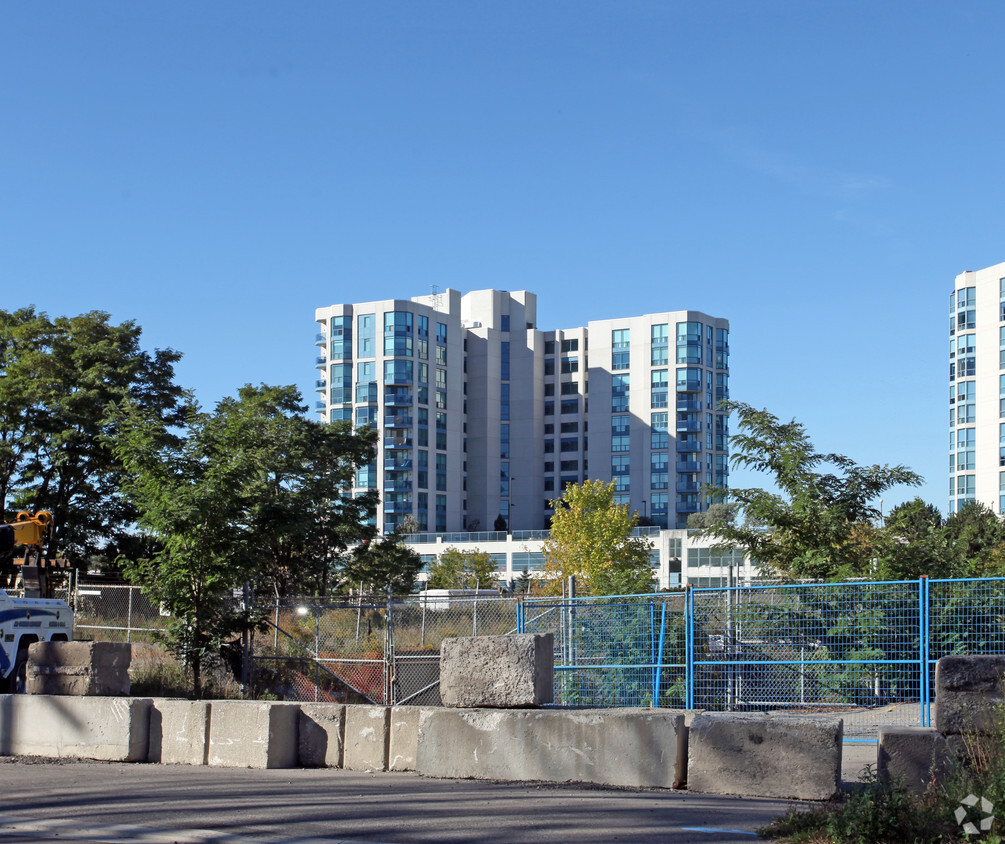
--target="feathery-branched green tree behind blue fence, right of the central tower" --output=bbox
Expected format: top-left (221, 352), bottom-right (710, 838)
top-left (704, 402), bottom-right (921, 580)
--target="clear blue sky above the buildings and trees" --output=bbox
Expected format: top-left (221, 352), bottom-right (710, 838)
top-left (0, 0), bottom-right (1005, 510)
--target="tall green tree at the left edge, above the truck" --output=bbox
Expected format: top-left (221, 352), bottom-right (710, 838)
top-left (0, 307), bottom-right (184, 560)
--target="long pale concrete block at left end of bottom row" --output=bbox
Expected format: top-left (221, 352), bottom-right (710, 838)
top-left (0, 694), bottom-right (151, 762)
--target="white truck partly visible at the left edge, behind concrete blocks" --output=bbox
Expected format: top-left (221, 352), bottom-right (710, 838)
top-left (0, 589), bottom-right (73, 693)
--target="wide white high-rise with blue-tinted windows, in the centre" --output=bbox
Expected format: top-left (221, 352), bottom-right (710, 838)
top-left (316, 289), bottom-right (729, 532)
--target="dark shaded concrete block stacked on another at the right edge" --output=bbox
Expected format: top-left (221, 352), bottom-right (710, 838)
top-left (936, 655), bottom-right (1005, 735)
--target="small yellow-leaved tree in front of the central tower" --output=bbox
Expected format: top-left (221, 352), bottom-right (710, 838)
top-left (544, 480), bottom-right (652, 595)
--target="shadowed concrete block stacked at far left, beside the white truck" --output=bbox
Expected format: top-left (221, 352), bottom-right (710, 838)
top-left (25, 642), bottom-right (132, 696)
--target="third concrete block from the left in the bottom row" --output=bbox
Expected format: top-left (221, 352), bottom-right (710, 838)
top-left (206, 700), bottom-right (299, 768)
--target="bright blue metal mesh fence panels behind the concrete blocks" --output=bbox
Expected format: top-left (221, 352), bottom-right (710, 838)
top-left (519, 578), bottom-right (1005, 736)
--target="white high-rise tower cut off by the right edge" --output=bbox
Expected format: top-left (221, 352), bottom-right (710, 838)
top-left (949, 263), bottom-right (1005, 512)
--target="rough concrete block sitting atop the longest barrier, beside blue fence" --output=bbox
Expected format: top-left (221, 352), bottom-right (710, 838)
top-left (439, 633), bottom-right (555, 707)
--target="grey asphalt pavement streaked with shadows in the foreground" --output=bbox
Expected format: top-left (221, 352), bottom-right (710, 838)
top-left (0, 759), bottom-right (791, 844)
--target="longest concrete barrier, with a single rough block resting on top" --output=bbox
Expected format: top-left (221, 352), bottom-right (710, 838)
top-left (416, 708), bottom-right (684, 789)
